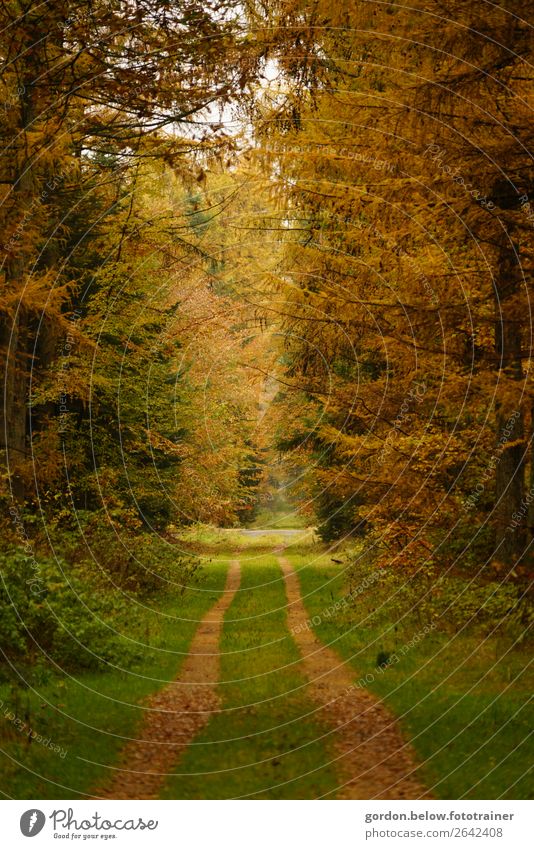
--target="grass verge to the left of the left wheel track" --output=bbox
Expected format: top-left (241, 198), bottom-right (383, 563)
top-left (0, 562), bottom-right (228, 799)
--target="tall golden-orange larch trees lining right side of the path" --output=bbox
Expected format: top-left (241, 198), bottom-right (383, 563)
top-left (260, 2), bottom-right (532, 569)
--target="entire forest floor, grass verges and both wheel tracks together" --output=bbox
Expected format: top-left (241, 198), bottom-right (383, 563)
top-left (0, 529), bottom-right (534, 799)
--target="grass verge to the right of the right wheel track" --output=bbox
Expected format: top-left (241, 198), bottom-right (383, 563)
top-left (288, 550), bottom-right (534, 799)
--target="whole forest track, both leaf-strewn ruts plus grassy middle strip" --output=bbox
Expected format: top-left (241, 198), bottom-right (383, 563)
top-left (90, 538), bottom-right (431, 799)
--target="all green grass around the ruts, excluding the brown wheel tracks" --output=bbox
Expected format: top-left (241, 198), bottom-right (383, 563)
top-left (0, 529), bottom-right (534, 799)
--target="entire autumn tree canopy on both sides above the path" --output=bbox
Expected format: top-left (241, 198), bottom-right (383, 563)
top-left (0, 0), bottom-right (534, 656)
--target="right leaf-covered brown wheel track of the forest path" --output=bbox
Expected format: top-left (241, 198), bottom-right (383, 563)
top-left (279, 557), bottom-right (431, 799)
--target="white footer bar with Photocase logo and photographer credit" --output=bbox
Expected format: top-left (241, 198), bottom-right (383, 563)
top-left (1, 800), bottom-right (534, 849)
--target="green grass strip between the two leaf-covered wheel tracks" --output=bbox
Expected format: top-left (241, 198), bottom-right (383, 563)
top-left (163, 556), bottom-right (337, 799)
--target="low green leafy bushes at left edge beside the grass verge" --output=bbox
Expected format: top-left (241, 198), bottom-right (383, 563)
top-left (0, 511), bottom-right (200, 681)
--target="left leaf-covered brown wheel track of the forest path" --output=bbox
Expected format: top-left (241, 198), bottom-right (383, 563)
top-left (94, 560), bottom-right (241, 799)
